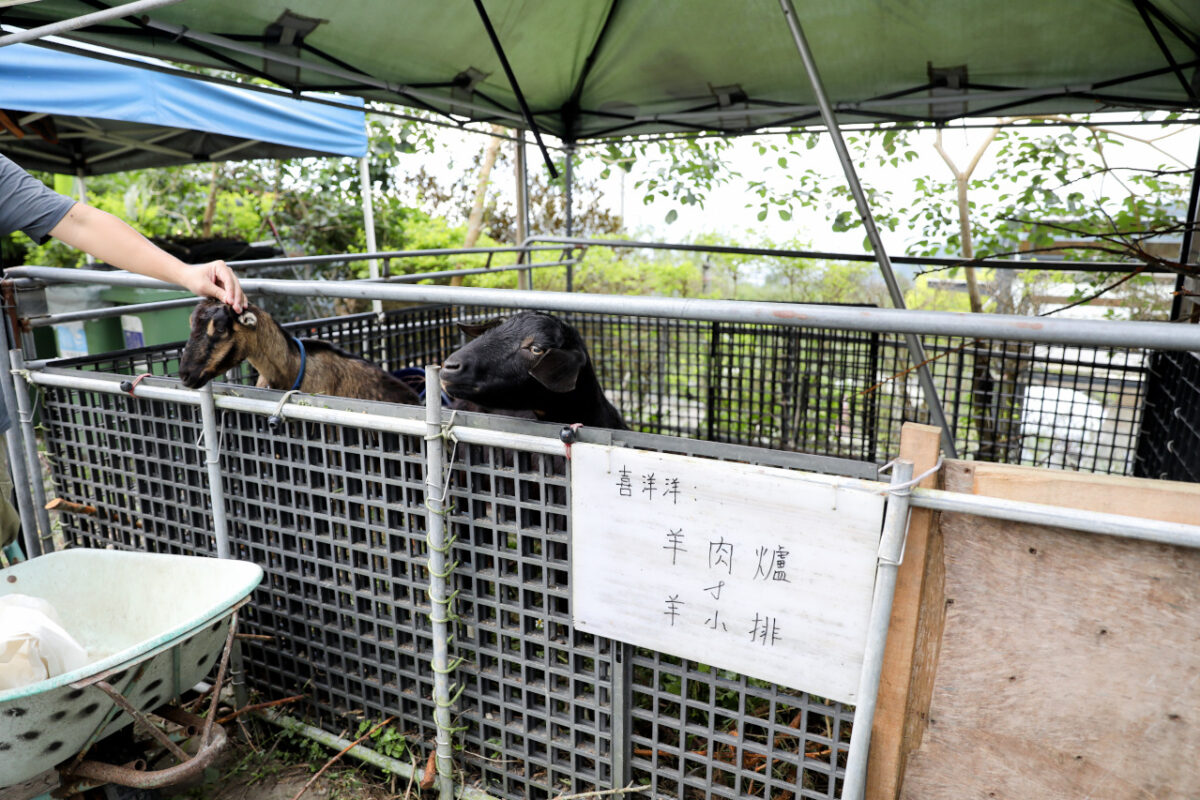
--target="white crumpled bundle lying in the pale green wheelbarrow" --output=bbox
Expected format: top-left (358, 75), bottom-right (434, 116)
top-left (0, 595), bottom-right (90, 692)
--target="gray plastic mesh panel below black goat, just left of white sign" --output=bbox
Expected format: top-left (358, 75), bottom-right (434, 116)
top-left (450, 446), bottom-right (613, 798)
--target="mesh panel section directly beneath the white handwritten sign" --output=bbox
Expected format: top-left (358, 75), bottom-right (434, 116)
top-left (630, 648), bottom-right (853, 800)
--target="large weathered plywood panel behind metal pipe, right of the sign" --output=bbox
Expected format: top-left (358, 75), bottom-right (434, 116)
top-left (900, 463), bottom-right (1200, 800)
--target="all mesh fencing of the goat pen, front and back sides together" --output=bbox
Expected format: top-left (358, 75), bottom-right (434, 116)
top-left (18, 283), bottom-right (1200, 798)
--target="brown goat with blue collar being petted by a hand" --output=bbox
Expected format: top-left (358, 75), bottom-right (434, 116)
top-left (179, 300), bottom-right (420, 404)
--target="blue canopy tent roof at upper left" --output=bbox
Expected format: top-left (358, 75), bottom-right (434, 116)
top-left (0, 39), bottom-right (367, 174)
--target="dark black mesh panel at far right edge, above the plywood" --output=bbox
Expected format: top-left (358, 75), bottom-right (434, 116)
top-left (1135, 353), bottom-right (1200, 482)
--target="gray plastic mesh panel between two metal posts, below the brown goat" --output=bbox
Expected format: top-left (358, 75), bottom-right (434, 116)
top-left (222, 414), bottom-right (434, 740)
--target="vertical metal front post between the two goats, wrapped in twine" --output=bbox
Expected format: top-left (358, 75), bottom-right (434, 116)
top-left (425, 366), bottom-right (455, 800)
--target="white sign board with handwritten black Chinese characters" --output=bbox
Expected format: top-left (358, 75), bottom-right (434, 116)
top-left (571, 444), bottom-right (884, 703)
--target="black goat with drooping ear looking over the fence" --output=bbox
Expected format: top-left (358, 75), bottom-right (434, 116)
top-left (442, 311), bottom-right (628, 429)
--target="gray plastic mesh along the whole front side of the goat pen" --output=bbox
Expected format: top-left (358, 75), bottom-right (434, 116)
top-left (43, 376), bottom-right (874, 798)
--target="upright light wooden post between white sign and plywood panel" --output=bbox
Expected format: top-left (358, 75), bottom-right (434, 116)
top-left (866, 422), bottom-right (941, 800)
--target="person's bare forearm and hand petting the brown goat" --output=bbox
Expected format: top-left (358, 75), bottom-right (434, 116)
top-left (49, 203), bottom-right (246, 313)
